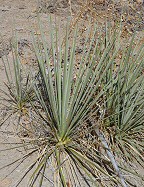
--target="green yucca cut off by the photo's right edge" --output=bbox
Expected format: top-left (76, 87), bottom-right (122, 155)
top-left (104, 30), bottom-right (144, 171)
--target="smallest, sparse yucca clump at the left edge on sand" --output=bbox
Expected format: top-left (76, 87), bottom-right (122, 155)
top-left (0, 36), bottom-right (35, 133)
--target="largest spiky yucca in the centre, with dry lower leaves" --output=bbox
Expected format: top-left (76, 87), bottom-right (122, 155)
top-left (16, 21), bottom-right (129, 187)
